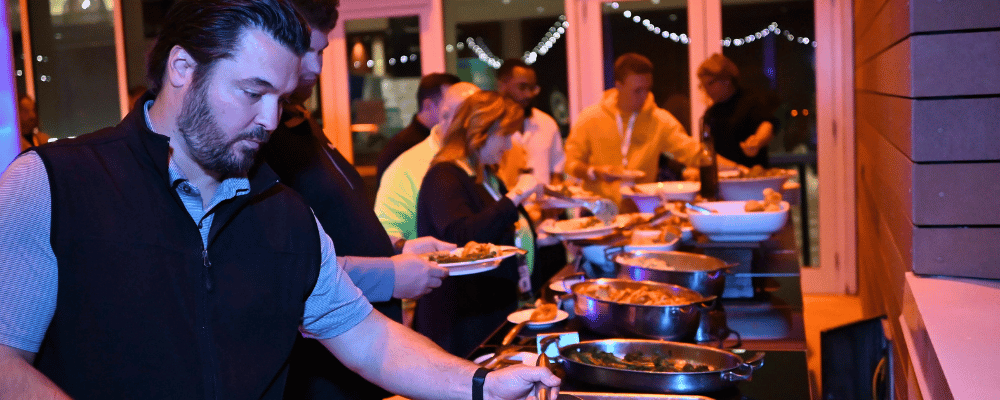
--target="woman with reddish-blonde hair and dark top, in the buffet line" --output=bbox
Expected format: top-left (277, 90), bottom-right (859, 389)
top-left (414, 91), bottom-right (542, 356)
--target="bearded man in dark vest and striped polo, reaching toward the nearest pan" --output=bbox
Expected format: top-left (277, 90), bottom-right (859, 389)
top-left (0, 0), bottom-right (559, 400)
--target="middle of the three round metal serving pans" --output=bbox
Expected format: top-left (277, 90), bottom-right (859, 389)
top-left (572, 278), bottom-right (715, 341)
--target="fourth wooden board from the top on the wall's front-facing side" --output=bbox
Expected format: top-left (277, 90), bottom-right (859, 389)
top-left (912, 162), bottom-right (1000, 225)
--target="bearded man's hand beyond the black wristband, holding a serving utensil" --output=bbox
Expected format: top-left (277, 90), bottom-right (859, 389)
top-left (483, 365), bottom-right (562, 400)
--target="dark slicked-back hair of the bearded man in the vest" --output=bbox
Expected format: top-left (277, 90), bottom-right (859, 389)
top-left (146, 0), bottom-right (309, 94)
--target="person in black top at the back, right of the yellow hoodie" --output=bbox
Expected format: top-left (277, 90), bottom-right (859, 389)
top-left (698, 53), bottom-right (778, 167)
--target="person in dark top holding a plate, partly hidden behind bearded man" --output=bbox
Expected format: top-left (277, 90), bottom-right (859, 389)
top-left (261, 0), bottom-right (454, 400)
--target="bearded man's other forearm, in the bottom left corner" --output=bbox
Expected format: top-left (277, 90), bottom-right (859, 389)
top-left (0, 345), bottom-right (69, 400)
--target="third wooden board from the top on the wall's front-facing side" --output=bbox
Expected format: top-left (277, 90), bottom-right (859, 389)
top-left (916, 97), bottom-right (1000, 162)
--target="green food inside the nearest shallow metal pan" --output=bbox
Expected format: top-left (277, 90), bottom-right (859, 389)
top-left (566, 349), bottom-right (716, 372)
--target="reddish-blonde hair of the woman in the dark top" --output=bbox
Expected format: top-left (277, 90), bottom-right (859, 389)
top-left (431, 91), bottom-right (524, 183)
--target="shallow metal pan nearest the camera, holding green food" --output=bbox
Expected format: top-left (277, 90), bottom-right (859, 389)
top-left (559, 339), bottom-right (764, 394)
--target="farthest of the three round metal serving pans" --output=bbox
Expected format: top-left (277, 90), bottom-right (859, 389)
top-left (612, 250), bottom-right (732, 296)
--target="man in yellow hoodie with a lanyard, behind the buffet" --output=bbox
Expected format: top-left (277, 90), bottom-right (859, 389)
top-left (566, 53), bottom-right (735, 202)
